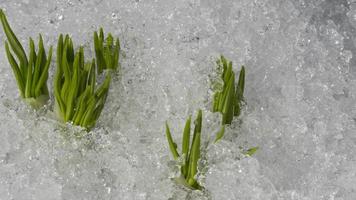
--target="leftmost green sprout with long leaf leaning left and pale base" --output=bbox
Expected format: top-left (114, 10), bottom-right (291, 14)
top-left (0, 9), bottom-right (52, 108)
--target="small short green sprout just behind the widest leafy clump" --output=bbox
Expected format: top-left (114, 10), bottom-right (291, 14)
top-left (94, 28), bottom-right (120, 74)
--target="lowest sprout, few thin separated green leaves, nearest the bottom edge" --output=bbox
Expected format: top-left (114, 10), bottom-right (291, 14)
top-left (166, 110), bottom-right (202, 190)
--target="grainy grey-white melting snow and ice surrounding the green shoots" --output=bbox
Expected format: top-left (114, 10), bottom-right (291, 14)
top-left (0, 0), bottom-right (356, 200)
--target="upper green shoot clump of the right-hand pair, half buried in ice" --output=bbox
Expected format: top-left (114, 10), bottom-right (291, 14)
top-left (213, 56), bottom-right (245, 125)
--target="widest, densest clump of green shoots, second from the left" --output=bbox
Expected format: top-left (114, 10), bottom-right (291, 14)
top-left (54, 34), bottom-right (111, 129)
